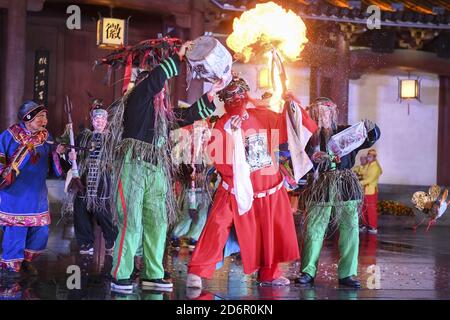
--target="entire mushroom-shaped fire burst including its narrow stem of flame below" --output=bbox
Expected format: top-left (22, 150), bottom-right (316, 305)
top-left (227, 2), bottom-right (308, 111)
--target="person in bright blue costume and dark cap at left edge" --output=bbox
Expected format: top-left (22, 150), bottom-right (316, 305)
top-left (0, 100), bottom-right (64, 277)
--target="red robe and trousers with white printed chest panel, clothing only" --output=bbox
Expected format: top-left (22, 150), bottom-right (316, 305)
top-left (189, 108), bottom-right (299, 281)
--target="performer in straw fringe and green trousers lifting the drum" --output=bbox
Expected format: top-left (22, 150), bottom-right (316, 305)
top-left (105, 42), bottom-right (223, 293)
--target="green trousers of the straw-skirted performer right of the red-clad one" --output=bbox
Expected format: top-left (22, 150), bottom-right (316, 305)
top-left (302, 200), bottom-right (359, 279)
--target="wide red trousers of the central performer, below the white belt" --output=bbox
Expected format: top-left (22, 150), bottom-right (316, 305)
top-left (189, 186), bottom-right (299, 281)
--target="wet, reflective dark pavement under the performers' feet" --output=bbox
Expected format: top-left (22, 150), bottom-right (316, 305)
top-left (0, 214), bottom-right (450, 300)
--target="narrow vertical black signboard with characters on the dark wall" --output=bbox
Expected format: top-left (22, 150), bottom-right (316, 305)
top-left (33, 50), bottom-right (50, 106)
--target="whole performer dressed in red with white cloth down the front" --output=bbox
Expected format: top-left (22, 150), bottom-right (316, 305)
top-left (187, 78), bottom-right (299, 288)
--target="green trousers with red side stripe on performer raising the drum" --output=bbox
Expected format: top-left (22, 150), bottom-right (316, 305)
top-left (111, 155), bottom-right (168, 280)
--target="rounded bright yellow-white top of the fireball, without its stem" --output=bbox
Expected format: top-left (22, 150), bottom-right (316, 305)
top-left (227, 2), bottom-right (308, 62)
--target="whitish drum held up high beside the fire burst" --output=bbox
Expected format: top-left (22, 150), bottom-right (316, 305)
top-left (186, 36), bottom-right (233, 86)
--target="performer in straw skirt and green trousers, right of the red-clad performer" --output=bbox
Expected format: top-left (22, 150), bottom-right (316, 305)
top-left (298, 98), bottom-right (380, 288)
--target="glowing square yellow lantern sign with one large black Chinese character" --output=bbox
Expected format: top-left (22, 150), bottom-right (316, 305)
top-left (97, 18), bottom-right (127, 49)
